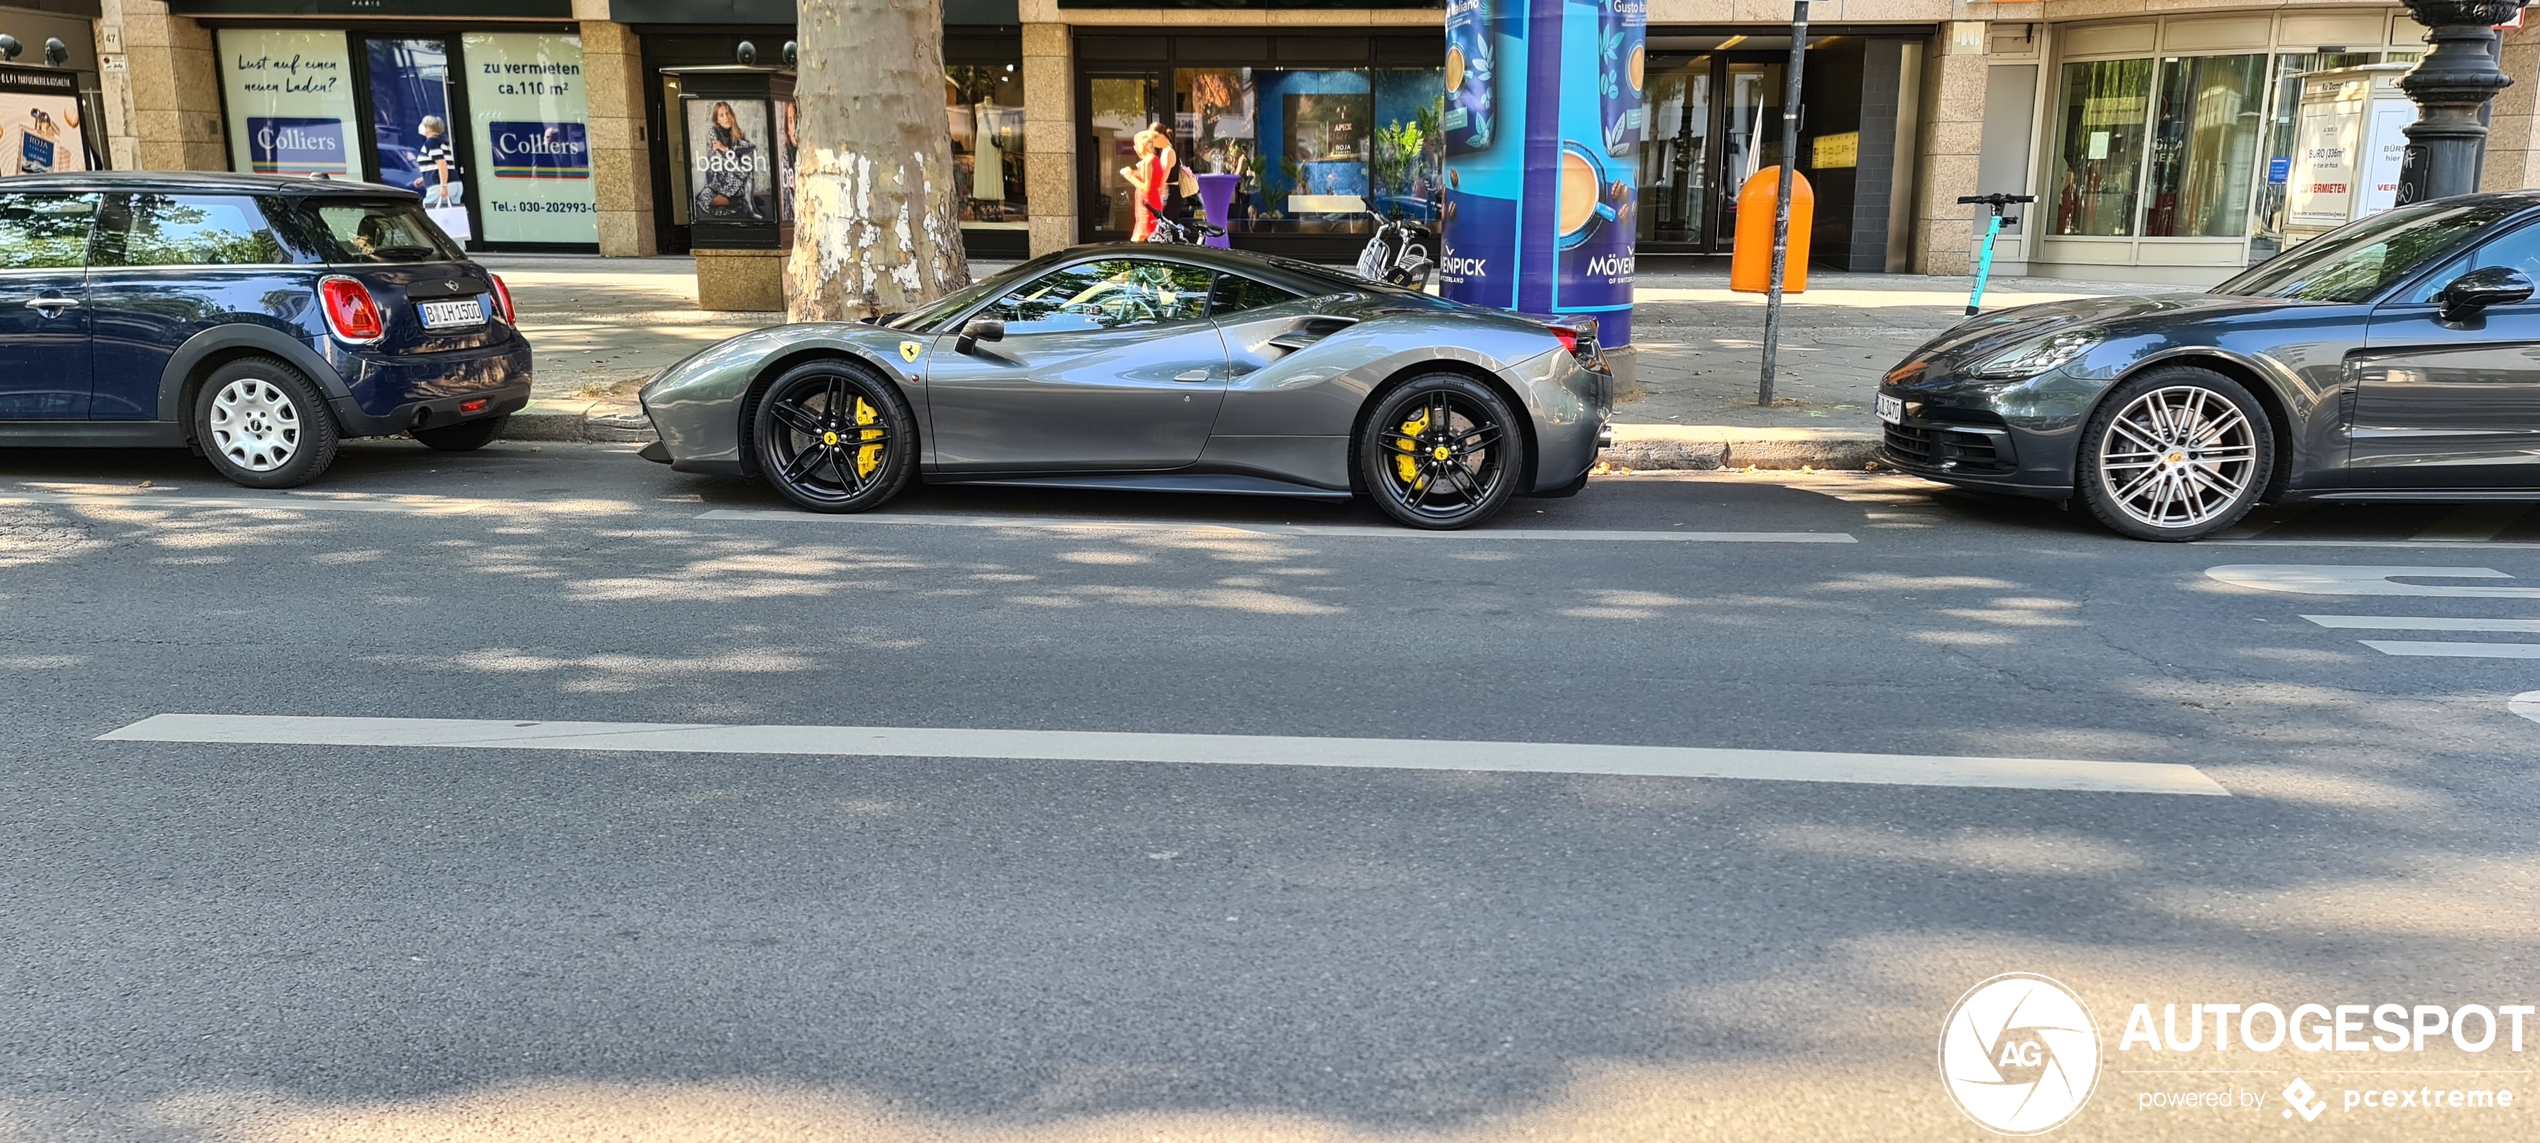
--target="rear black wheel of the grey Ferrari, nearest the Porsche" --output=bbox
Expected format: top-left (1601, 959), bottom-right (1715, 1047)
top-left (1359, 373), bottom-right (1527, 528)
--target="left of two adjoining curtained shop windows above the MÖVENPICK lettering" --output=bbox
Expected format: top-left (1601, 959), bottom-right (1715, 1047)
top-left (2050, 58), bottom-right (2151, 236)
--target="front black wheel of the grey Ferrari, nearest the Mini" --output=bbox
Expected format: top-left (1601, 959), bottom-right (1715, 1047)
top-left (749, 361), bottom-right (917, 513)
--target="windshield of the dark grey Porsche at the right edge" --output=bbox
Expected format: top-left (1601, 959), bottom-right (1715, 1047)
top-left (2212, 201), bottom-right (2525, 302)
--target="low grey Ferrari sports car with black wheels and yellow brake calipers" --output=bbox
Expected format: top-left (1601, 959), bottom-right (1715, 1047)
top-left (640, 244), bottom-right (1613, 528)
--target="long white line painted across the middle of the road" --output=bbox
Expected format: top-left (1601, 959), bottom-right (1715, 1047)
top-left (99, 714), bottom-right (2230, 798)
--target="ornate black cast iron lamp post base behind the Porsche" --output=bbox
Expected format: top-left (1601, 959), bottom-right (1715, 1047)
top-left (2398, 0), bottom-right (2522, 203)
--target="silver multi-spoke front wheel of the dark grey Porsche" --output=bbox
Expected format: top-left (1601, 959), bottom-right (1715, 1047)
top-left (2080, 368), bottom-right (2276, 541)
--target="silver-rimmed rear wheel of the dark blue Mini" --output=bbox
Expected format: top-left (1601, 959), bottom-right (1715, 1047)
top-left (193, 358), bottom-right (335, 488)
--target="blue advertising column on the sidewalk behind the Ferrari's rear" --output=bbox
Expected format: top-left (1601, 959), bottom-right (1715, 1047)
top-left (1438, 0), bottom-right (1646, 345)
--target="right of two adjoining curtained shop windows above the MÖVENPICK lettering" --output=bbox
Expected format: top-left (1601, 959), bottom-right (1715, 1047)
top-left (2144, 56), bottom-right (2266, 239)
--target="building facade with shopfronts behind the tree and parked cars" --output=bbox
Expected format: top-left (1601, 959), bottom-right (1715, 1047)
top-left (19, 0), bottom-right (2540, 284)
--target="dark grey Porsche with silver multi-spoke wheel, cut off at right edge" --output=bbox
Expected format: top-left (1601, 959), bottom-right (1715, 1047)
top-left (1877, 191), bottom-right (2540, 541)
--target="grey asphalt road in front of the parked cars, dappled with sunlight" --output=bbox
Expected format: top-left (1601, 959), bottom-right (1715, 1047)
top-left (0, 445), bottom-right (2540, 1143)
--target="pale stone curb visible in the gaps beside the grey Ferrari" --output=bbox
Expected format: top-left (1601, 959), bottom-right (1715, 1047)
top-left (503, 401), bottom-right (1880, 472)
